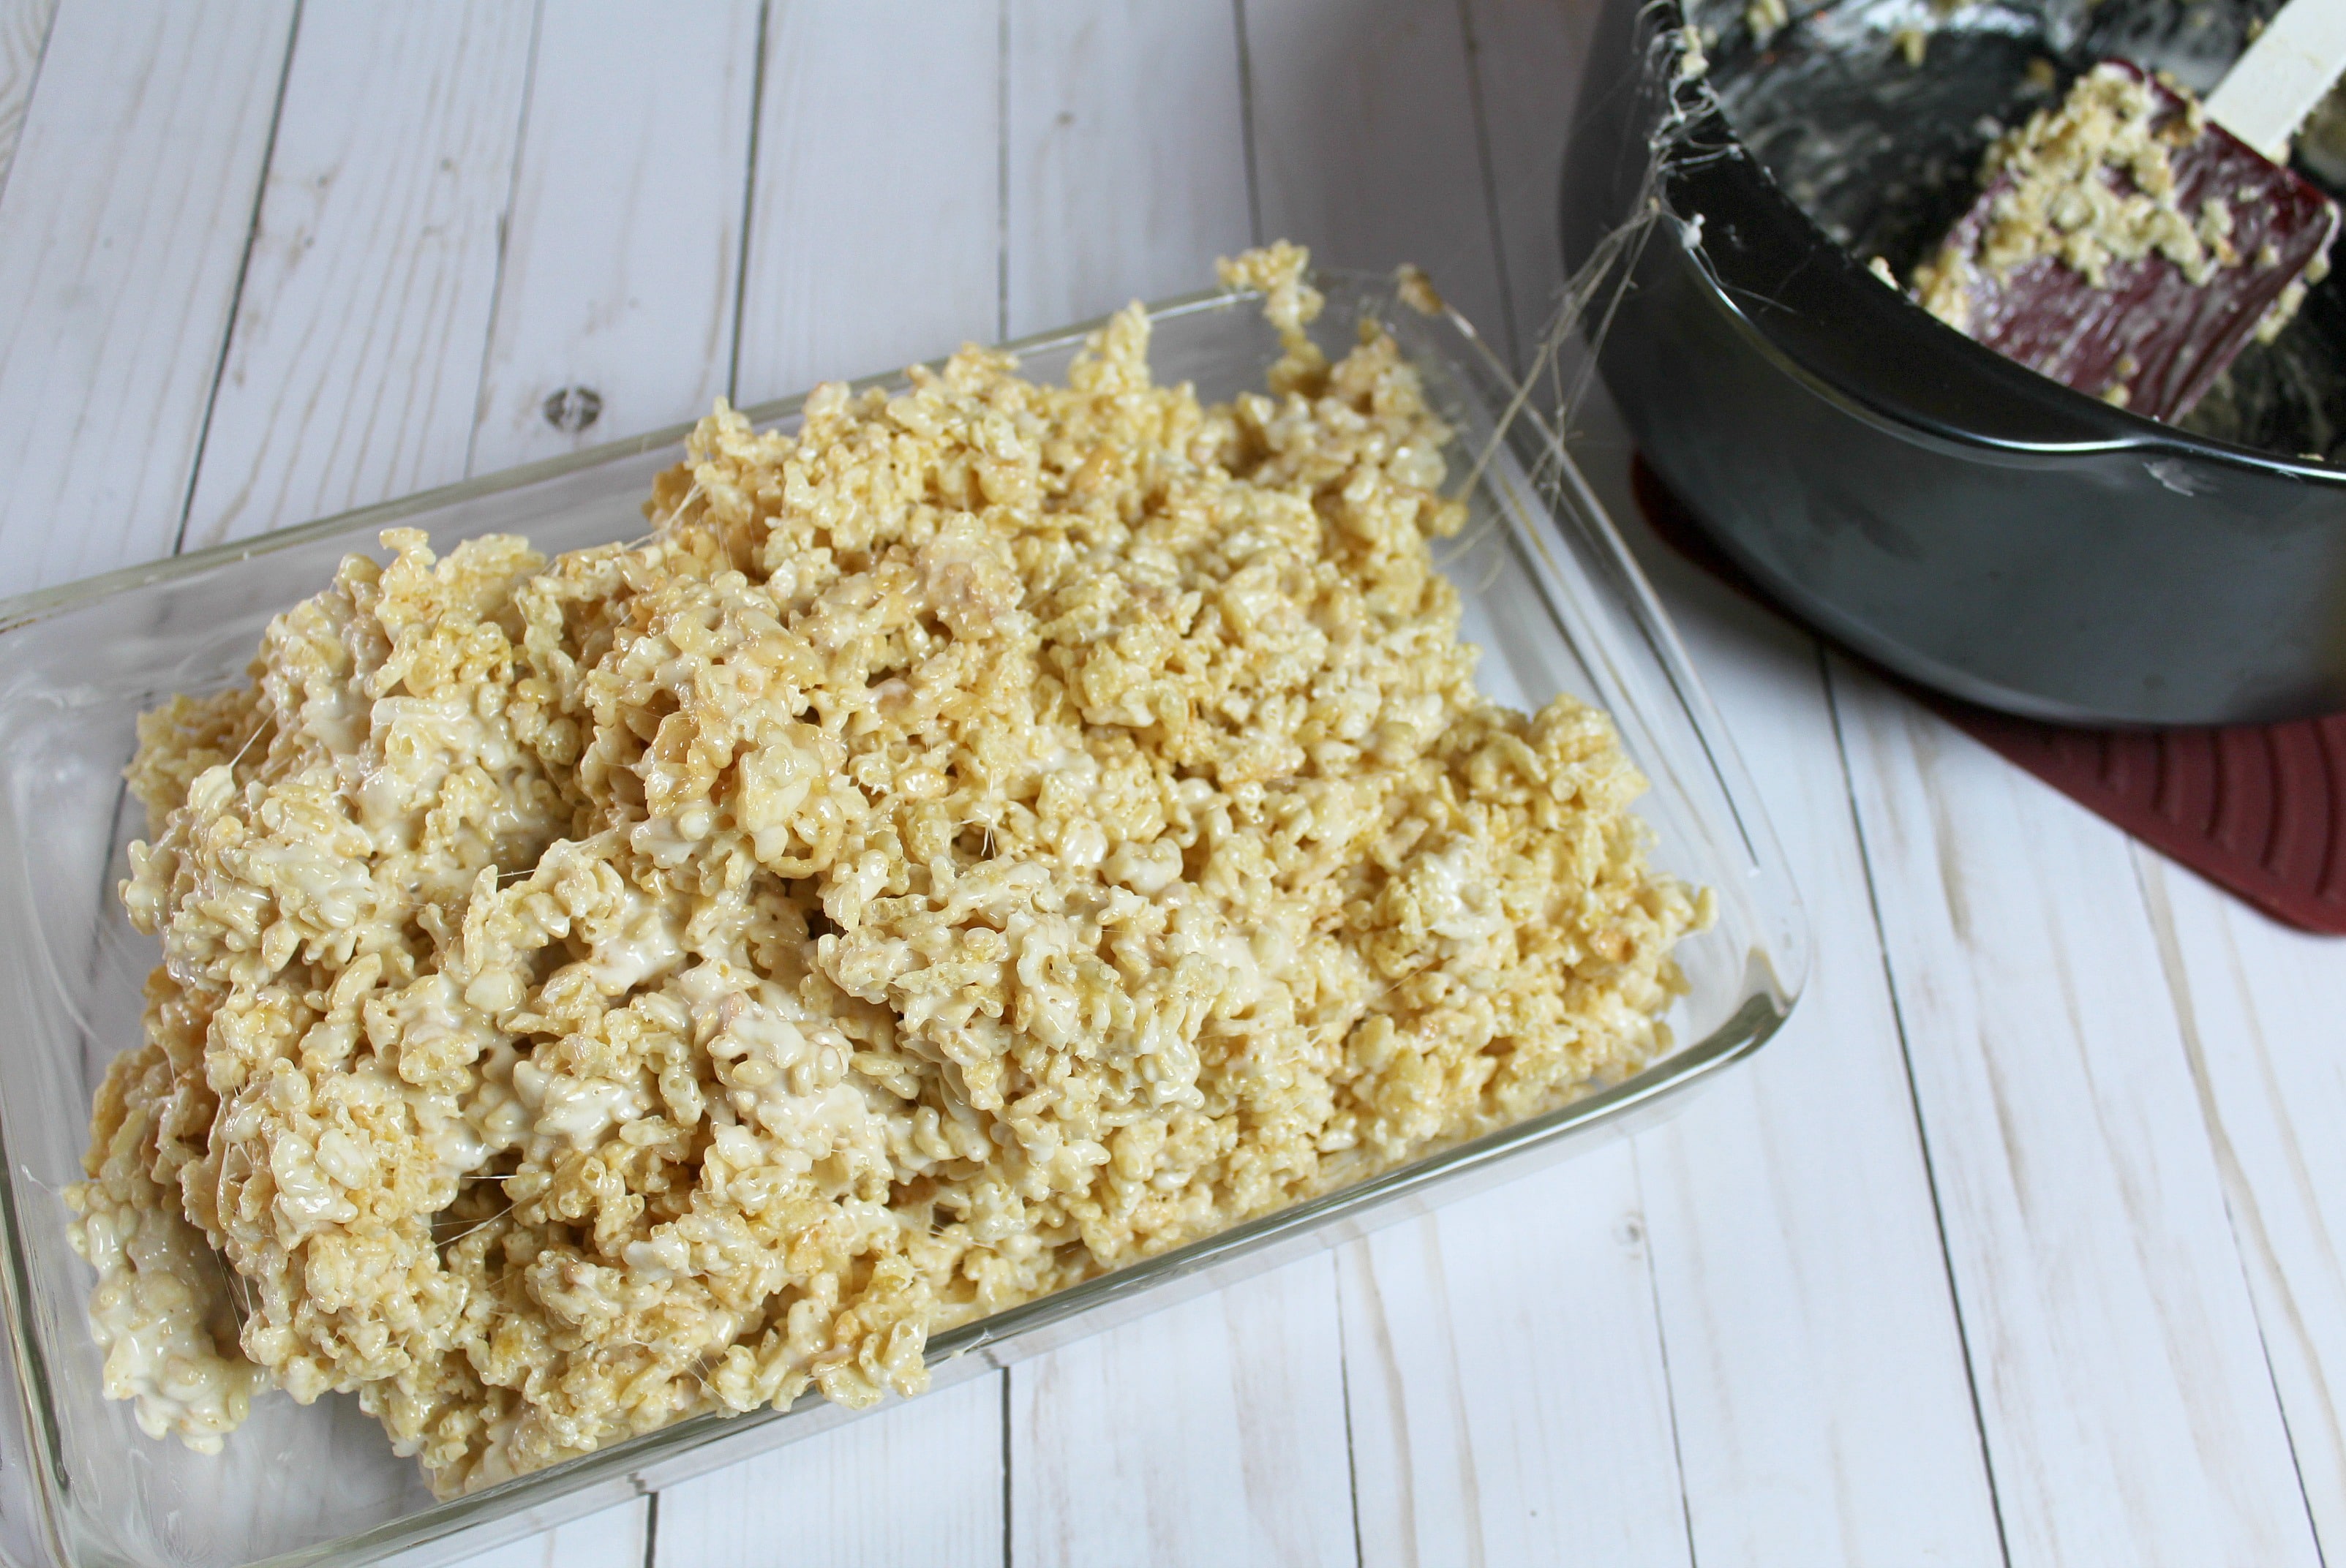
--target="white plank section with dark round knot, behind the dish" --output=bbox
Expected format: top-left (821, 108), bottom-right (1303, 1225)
top-left (467, 0), bottom-right (760, 473)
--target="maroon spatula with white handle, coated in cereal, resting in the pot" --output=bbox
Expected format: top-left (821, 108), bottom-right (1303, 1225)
top-left (1917, 0), bottom-right (2346, 420)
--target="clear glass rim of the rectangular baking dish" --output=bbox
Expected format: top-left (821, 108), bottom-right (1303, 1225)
top-left (0, 267), bottom-right (1809, 1568)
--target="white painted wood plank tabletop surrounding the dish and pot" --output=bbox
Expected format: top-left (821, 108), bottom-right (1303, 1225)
top-left (0, 0), bottom-right (2346, 1568)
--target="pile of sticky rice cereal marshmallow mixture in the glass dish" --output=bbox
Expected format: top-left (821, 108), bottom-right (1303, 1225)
top-left (68, 246), bottom-right (1708, 1493)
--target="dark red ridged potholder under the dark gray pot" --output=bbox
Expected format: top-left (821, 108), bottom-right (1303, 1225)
top-left (1633, 459), bottom-right (2346, 935)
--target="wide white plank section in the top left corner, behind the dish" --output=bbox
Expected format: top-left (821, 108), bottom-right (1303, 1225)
top-left (0, 4), bottom-right (293, 593)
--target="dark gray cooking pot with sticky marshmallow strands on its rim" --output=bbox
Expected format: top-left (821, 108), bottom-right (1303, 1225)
top-left (1563, 0), bottom-right (2346, 724)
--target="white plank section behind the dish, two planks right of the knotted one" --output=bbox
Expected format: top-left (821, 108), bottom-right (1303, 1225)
top-left (1001, 0), bottom-right (1253, 335)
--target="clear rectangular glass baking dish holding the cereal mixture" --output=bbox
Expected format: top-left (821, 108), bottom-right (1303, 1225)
top-left (0, 274), bottom-right (1806, 1568)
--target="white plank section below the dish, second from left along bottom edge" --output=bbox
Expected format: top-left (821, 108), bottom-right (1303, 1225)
top-left (656, 1373), bottom-right (1001, 1568)
